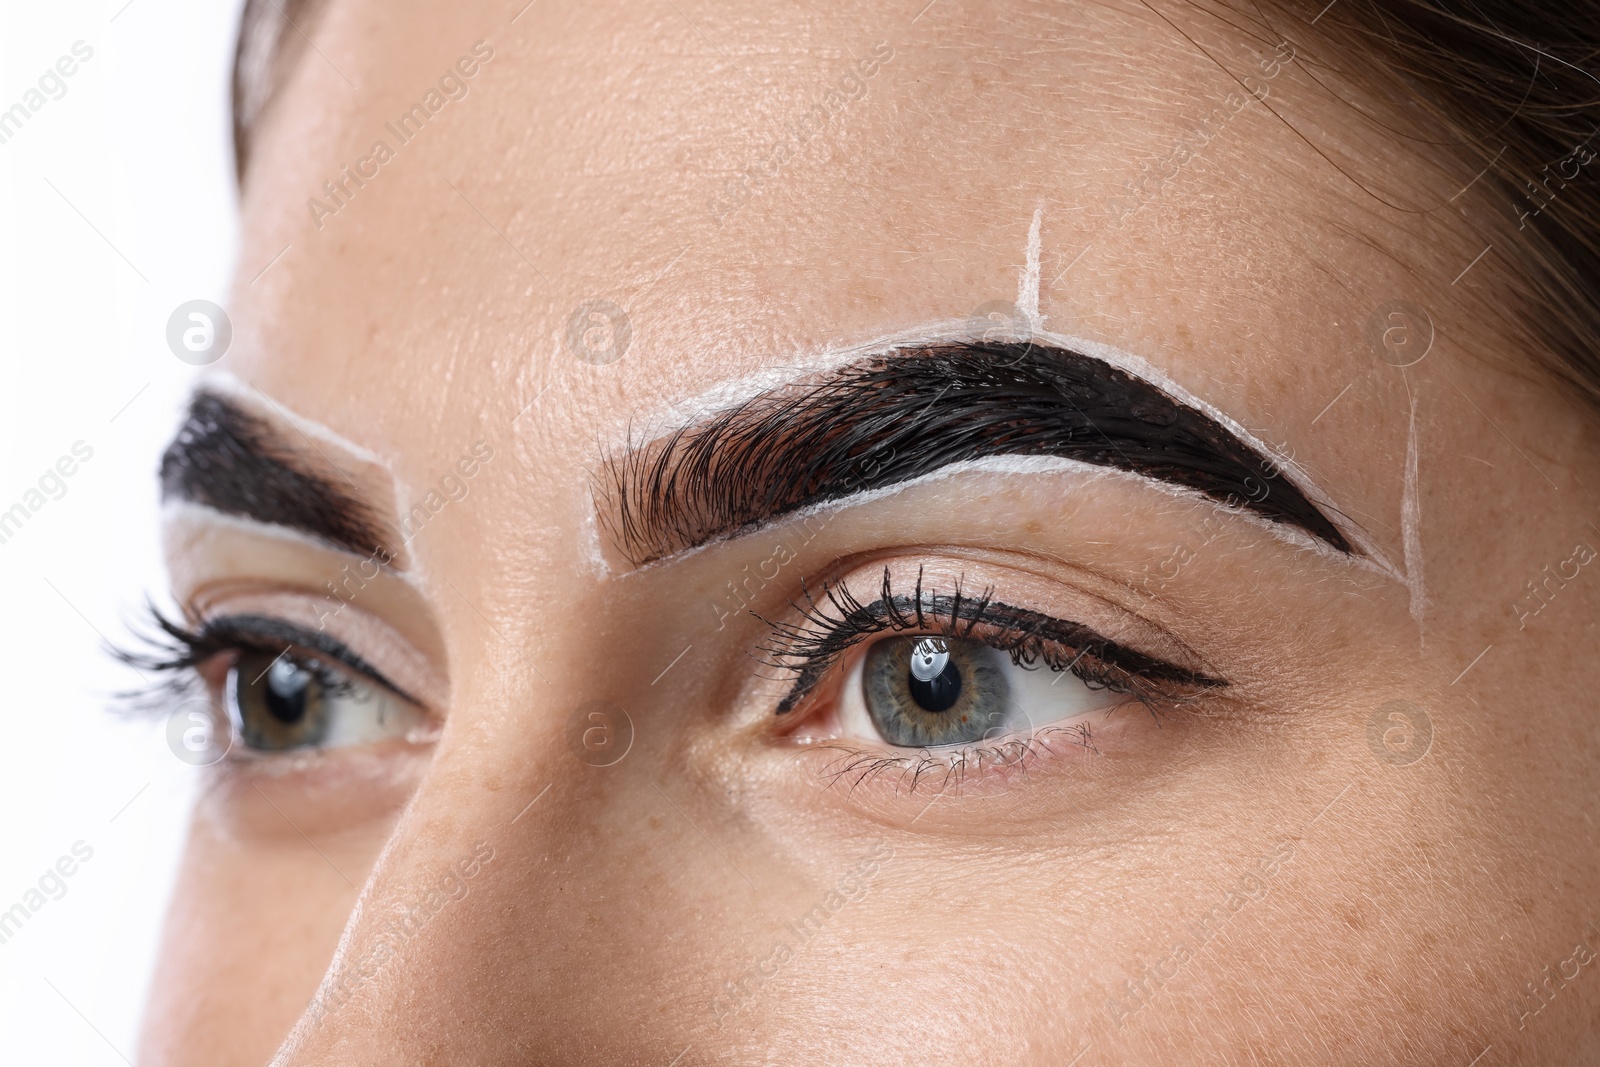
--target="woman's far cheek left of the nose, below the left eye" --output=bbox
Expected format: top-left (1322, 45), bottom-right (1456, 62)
top-left (141, 755), bottom-right (421, 1067)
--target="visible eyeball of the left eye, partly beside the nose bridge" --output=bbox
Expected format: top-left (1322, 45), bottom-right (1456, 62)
top-left (222, 649), bottom-right (424, 752)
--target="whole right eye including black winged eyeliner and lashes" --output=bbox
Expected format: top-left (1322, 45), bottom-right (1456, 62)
top-left (763, 566), bottom-right (1227, 766)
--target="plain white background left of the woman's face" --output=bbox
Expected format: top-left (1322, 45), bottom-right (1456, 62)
top-left (0, 0), bottom-right (238, 1065)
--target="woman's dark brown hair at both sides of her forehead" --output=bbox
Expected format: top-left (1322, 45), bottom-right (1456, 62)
top-left (234, 0), bottom-right (1600, 403)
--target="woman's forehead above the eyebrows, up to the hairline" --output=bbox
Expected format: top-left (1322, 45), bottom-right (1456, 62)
top-left (232, 0), bottom-right (1427, 499)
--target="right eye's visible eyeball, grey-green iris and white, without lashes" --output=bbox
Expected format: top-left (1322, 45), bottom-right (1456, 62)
top-left (838, 637), bottom-right (1128, 749)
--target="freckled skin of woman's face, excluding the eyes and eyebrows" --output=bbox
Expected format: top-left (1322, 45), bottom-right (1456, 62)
top-left (141, 0), bottom-right (1600, 1067)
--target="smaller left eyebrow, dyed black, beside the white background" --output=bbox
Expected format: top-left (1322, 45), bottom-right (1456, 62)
top-left (160, 392), bottom-right (394, 558)
